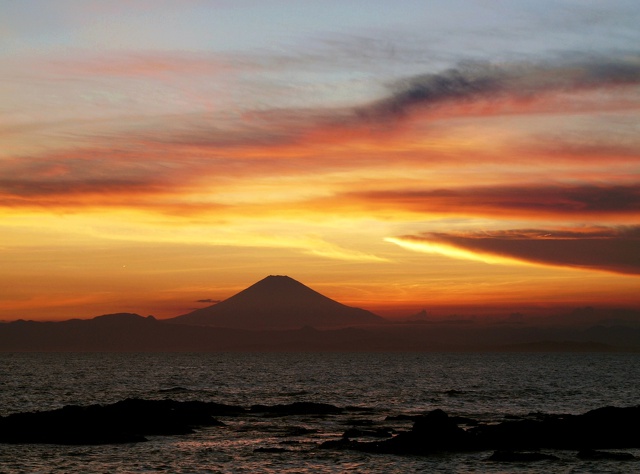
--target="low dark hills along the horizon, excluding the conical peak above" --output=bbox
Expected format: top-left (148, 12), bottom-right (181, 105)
top-left (0, 314), bottom-right (640, 352)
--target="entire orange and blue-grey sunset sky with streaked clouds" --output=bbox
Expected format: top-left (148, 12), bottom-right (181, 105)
top-left (0, 0), bottom-right (640, 320)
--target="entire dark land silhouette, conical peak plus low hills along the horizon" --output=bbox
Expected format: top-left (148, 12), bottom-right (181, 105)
top-left (0, 276), bottom-right (640, 352)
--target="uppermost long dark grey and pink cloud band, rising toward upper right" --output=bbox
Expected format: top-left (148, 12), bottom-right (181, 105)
top-left (146, 53), bottom-right (640, 154)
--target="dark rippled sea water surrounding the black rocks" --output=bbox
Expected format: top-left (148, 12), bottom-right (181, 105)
top-left (0, 353), bottom-right (640, 473)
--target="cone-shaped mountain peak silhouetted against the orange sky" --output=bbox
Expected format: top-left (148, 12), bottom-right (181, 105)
top-left (168, 275), bottom-right (386, 329)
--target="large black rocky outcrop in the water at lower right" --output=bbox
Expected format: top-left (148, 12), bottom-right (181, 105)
top-left (321, 406), bottom-right (640, 458)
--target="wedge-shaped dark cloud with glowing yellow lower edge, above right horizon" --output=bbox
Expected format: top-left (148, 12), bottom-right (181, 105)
top-left (389, 226), bottom-right (640, 276)
